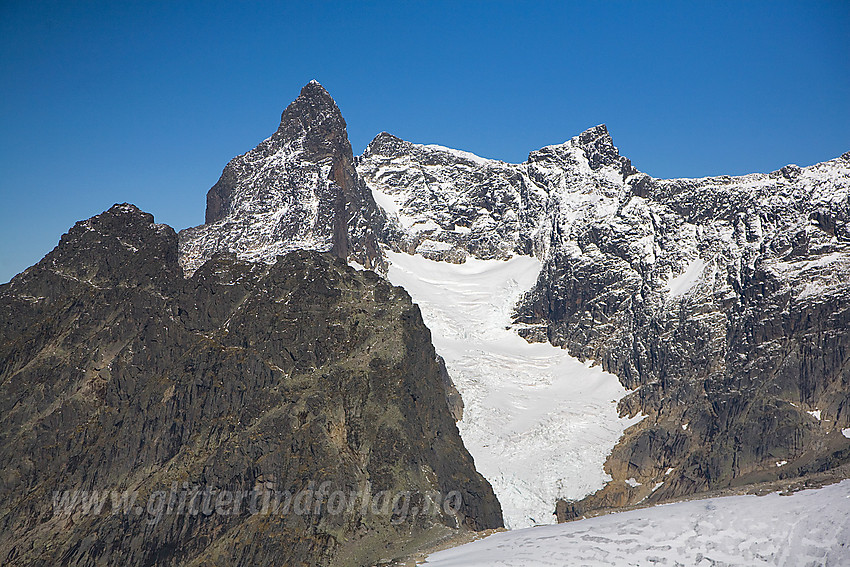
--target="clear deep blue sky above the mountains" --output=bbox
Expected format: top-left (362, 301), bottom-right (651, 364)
top-left (0, 0), bottom-right (850, 282)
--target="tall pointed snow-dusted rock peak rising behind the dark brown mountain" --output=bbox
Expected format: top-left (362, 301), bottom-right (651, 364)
top-left (180, 81), bottom-right (385, 273)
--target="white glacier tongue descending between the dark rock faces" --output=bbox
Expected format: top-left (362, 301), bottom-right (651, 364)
top-left (387, 252), bottom-right (640, 528)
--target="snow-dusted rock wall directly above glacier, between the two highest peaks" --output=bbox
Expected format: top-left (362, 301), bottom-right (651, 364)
top-left (357, 133), bottom-right (545, 262)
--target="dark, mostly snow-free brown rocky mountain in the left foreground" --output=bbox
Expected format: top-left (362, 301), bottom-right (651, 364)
top-left (0, 205), bottom-right (501, 565)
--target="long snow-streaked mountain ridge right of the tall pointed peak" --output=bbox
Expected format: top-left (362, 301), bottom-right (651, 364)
top-left (358, 126), bottom-right (850, 518)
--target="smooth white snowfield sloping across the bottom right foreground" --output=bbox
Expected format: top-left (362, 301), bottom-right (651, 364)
top-left (424, 480), bottom-right (850, 567)
